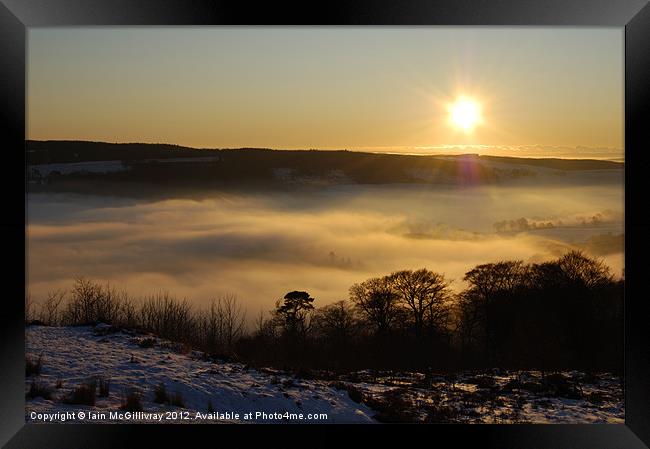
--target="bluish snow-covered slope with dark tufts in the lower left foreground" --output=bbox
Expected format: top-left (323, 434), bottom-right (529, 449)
top-left (25, 326), bottom-right (374, 423)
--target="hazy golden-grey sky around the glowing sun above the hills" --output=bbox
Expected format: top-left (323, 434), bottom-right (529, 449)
top-left (27, 27), bottom-right (624, 157)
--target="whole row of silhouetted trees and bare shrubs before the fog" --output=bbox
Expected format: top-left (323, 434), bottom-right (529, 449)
top-left (27, 251), bottom-right (624, 371)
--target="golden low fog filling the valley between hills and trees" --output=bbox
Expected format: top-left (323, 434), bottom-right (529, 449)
top-left (27, 178), bottom-right (624, 317)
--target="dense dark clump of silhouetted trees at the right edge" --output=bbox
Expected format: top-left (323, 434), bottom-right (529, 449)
top-left (458, 251), bottom-right (623, 369)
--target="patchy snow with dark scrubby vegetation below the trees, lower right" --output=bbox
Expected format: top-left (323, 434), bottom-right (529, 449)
top-left (344, 370), bottom-right (625, 424)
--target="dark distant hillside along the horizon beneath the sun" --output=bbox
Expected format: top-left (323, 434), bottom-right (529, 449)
top-left (27, 141), bottom-right (624, 192)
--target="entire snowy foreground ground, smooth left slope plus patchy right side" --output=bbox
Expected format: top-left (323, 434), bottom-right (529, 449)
top-left (25, 325), bottom-right (625, 423)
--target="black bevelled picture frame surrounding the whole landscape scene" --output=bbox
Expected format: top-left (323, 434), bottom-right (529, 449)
top-left (0, 0), bottom-right (650, 449)
